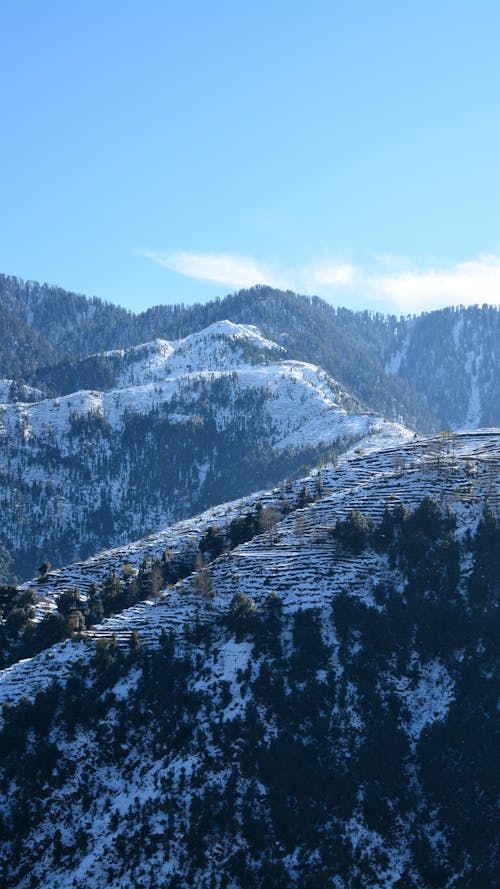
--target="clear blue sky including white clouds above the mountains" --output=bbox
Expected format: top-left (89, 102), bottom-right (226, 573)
top-left (0, 0), bottom-right (500, 313)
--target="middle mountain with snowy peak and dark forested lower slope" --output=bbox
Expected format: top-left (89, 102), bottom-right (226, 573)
top-left (0, 321), bottom-right (410, 578)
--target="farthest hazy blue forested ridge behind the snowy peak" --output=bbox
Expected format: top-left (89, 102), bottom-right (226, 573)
top-left (0, 276), bottom-right (500, 432)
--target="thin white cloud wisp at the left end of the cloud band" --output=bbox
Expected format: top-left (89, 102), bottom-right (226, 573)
top-left (142, 250), bottom-right (289, 288)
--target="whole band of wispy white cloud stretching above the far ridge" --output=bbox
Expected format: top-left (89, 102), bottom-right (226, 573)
top-left (141, 250), bottom-right (500, 313)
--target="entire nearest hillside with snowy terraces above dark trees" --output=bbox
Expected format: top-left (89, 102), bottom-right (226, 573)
top-left (0, 430), bottom-right (500, 889)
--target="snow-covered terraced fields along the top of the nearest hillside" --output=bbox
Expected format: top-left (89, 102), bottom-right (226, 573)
top-left (0, 431), bottom-right (500, 702)
